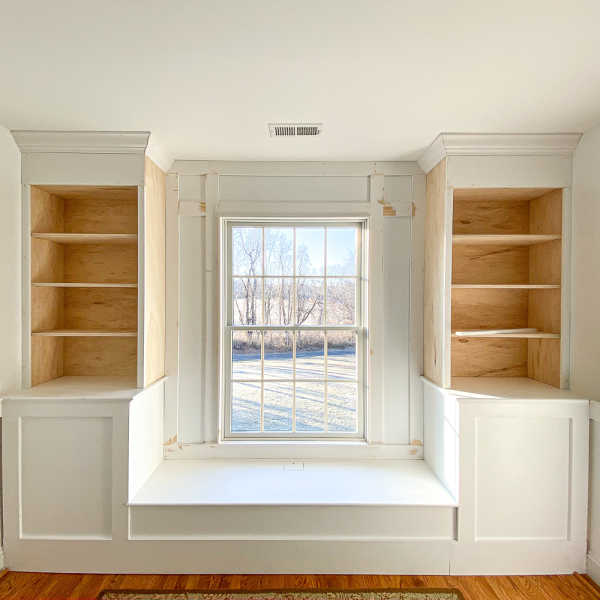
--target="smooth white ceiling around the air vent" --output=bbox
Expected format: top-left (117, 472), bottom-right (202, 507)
top-left (0, 0), bottom-right (600, 160)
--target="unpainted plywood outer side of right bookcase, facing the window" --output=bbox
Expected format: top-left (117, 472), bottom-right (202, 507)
top-left (423, 160), bottom-right (450, 387)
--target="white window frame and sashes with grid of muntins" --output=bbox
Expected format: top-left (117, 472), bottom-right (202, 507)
top-left (221, 218), bottom-right (367, 441)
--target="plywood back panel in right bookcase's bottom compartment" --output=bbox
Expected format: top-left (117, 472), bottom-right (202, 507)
top-left (452, 338), bottom-right (528, 377)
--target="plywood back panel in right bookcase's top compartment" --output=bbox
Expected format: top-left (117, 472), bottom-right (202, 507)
top-left (452, 199), bottom-right (529, 234)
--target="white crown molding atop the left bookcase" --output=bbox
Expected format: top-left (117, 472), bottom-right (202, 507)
top-left (11, 130), bottom-right (173, 173)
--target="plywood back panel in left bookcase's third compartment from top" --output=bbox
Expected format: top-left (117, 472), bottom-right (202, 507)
top-left (64, 288), bottom-right (137, 330)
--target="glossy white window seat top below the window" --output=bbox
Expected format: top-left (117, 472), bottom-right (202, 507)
top-left (129, 460), bottom-right (457, 506)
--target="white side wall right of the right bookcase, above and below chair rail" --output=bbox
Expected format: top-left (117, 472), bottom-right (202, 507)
top-left (571, 126), bottom-right (600, 583)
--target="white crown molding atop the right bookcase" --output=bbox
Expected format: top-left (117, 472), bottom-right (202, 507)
top-left (417, 133), bottom-right (582, 173)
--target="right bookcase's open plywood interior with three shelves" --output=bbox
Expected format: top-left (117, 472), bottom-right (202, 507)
top-left (451, 188), bottom-right (563, 387)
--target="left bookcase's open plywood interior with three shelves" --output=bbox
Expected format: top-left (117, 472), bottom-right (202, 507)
top-left (30, 186), bottom-right (138, 385)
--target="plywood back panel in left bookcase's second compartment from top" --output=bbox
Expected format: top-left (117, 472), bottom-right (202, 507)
top-left (63, 240), bottom-right (138, 283)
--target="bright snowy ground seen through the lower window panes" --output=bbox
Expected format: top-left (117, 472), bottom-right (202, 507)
top-left (231, 348), bottom-right (357, 433)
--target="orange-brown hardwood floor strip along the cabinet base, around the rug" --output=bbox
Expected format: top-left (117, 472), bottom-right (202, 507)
top-left (0, 571), bottom-right (600, 600)
